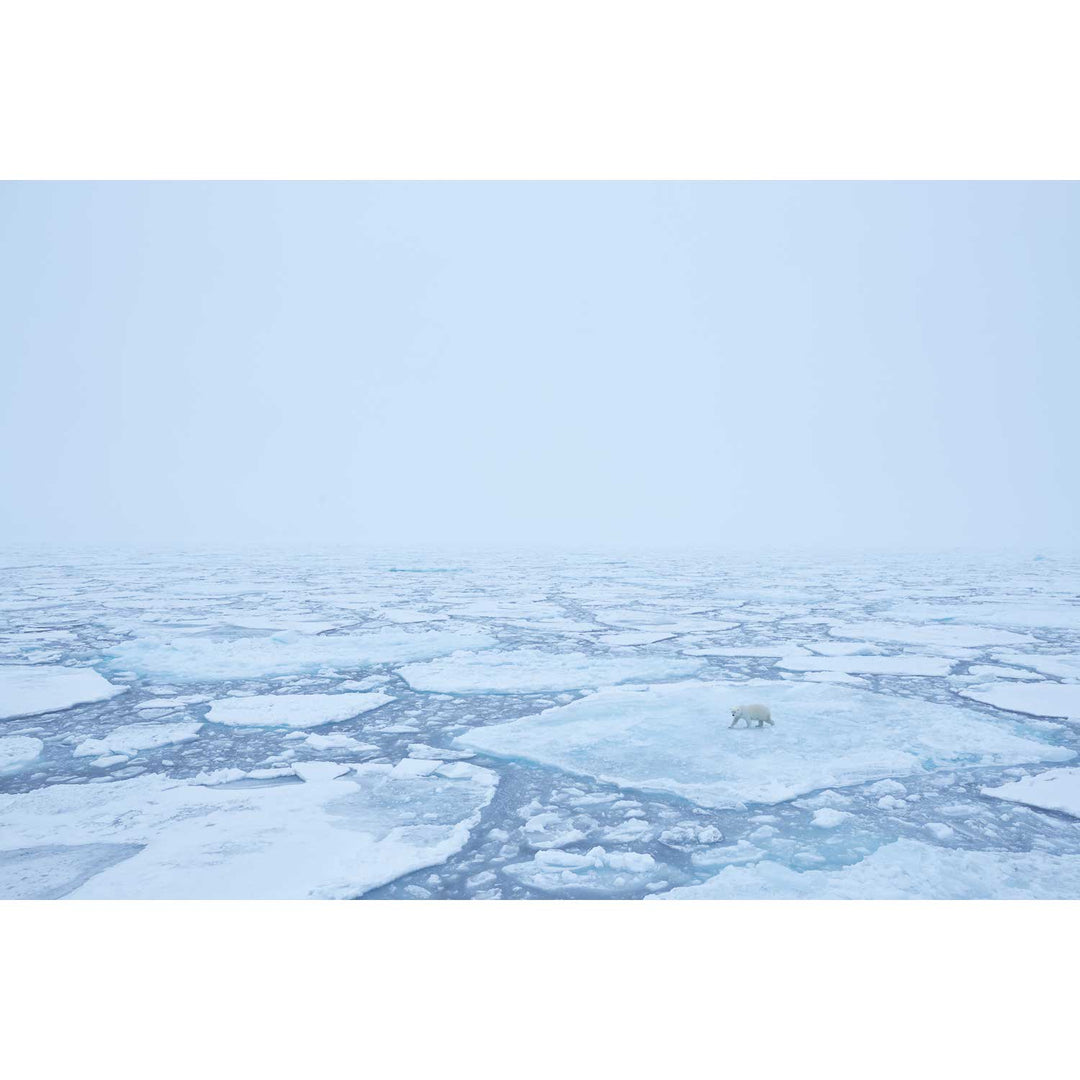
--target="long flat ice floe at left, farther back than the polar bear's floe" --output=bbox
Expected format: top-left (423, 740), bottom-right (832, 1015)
top-left (106, 629), bottom-right (495, 680)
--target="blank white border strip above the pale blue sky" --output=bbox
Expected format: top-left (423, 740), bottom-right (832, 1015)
top-left (6, 0), bottom-right (1080, 179)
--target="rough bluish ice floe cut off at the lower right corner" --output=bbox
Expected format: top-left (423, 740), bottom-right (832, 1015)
top-left (659, 839), bottom-right (1080, 900)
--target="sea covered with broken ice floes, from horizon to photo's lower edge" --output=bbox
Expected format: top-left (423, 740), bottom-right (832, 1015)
top-left (0, 549), bottom-right (1080, 900)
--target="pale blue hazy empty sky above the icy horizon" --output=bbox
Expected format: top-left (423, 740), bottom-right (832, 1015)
top-left (0, 183), bottom-right (1080, 548)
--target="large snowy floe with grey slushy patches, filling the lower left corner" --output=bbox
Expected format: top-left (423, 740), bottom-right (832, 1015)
top-left (0, 761), bottom-right (497, 900)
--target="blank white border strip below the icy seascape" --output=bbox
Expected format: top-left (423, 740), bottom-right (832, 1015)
top-left (0, 901), bottom-right (1080, 1080)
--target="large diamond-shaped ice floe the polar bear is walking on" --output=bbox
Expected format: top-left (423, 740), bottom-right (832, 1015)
top-left (457, 681), bottom-right (1075, 807)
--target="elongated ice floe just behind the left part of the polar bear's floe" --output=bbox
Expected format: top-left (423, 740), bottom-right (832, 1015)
top-left (397, 649), bottom-right (700, 693)
